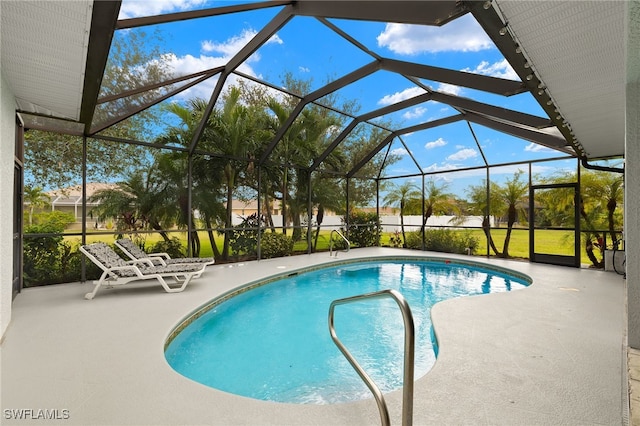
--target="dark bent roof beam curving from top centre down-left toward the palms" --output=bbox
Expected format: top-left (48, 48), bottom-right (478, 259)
top-left (189, 6), bottom-right (293, 153)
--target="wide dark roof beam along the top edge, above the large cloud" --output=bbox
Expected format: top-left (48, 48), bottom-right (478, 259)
top-left (295, 0), bottom-right (468, 26)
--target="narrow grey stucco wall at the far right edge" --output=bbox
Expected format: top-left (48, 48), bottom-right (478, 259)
top-left (624, 0), bottom-right (640, 349)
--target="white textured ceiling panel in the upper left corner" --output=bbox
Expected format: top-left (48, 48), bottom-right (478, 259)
top-left (0, 0), bottom-right (93, 120)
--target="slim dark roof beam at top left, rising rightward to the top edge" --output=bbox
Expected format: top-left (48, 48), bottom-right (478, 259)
top-left (116, 1), bottom-right (293, 30)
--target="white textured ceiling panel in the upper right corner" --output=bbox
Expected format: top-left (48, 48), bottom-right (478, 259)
top-left (496, 0), bottom-right (625, 158)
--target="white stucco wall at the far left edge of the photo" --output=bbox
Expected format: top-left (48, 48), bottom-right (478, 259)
top-left (0, 69), bottom-right (15, 339)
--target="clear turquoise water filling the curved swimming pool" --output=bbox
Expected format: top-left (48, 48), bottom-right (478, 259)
top-left (165, 260), bottom-right (529, 404)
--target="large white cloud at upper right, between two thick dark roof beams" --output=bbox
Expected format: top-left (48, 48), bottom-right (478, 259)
top-left (377, 14), bottom-right (493, 55)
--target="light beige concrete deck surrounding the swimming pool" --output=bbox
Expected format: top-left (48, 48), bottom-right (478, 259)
top-left (0, 248), bottom-right (628, 425)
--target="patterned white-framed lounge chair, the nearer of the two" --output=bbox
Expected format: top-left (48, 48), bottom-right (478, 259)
top-left (80, 243), bottom-right (206, 300)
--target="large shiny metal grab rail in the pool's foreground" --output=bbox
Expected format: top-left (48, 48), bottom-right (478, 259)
top-left (329, 290), bottom-right (415, 426)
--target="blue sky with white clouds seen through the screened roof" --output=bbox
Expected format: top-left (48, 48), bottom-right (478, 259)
top-left (115, 0), bottom-right (575, 195)
